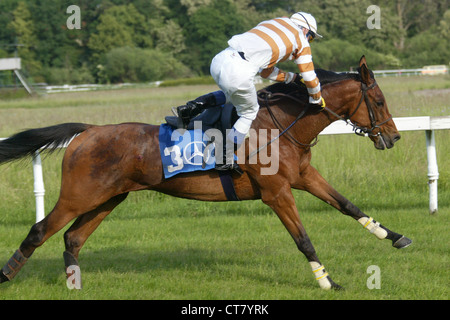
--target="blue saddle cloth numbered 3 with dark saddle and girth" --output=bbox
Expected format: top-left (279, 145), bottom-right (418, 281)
top-left (159, 104), bottom-right (239, 200)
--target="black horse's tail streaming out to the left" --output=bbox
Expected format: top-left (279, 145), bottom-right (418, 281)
top-left (0, 123), bottom-right (91, 164)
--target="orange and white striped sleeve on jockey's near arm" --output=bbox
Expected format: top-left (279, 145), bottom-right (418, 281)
top-left (295, 46), bottom-right (322, 101)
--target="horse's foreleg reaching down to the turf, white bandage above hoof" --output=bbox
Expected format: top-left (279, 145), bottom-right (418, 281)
top-left (261, 180), bottom-right (341, 289)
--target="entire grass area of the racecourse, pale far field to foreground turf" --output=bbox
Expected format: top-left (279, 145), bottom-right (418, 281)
top-left (0, 77), bottom-right (450, 300)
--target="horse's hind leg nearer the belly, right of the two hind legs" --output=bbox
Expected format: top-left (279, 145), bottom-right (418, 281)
top-left (63, 193), bottom-right (128, 288)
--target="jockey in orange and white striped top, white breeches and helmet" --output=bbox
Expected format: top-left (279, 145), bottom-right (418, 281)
top-left (176, 12), bottom-right (325, 170)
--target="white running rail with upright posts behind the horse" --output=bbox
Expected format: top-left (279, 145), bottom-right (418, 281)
top-left (0, 116), bottom-right (450, 222)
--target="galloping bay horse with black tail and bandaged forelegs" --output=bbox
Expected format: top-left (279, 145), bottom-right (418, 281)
top-left (0, 56), bottom-right (411, 289)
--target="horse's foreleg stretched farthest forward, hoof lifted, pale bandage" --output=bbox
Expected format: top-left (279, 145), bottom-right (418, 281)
top-left (294, 166), bottom-right (412, 249)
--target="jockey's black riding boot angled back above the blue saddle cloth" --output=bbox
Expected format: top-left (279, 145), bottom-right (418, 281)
top-left (176, 91), bottom-right (226, 129)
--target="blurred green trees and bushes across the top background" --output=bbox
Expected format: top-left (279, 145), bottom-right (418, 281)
top-left (0, 0), bottom-right (450, 86)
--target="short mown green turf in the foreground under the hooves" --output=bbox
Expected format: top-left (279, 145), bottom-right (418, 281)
top-left (0, 206), bottom-right (449, 300)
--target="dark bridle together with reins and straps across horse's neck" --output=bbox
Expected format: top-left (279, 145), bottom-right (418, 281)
top-left (249, 81), bottom-right (392, 159)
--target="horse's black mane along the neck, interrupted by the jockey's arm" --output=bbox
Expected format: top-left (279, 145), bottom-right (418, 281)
top-left (265, 68), bottom-right (361, 97)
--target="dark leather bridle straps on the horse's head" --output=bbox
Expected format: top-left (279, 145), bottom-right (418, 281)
top-left (325, 81), bottom-right (392, 137)
